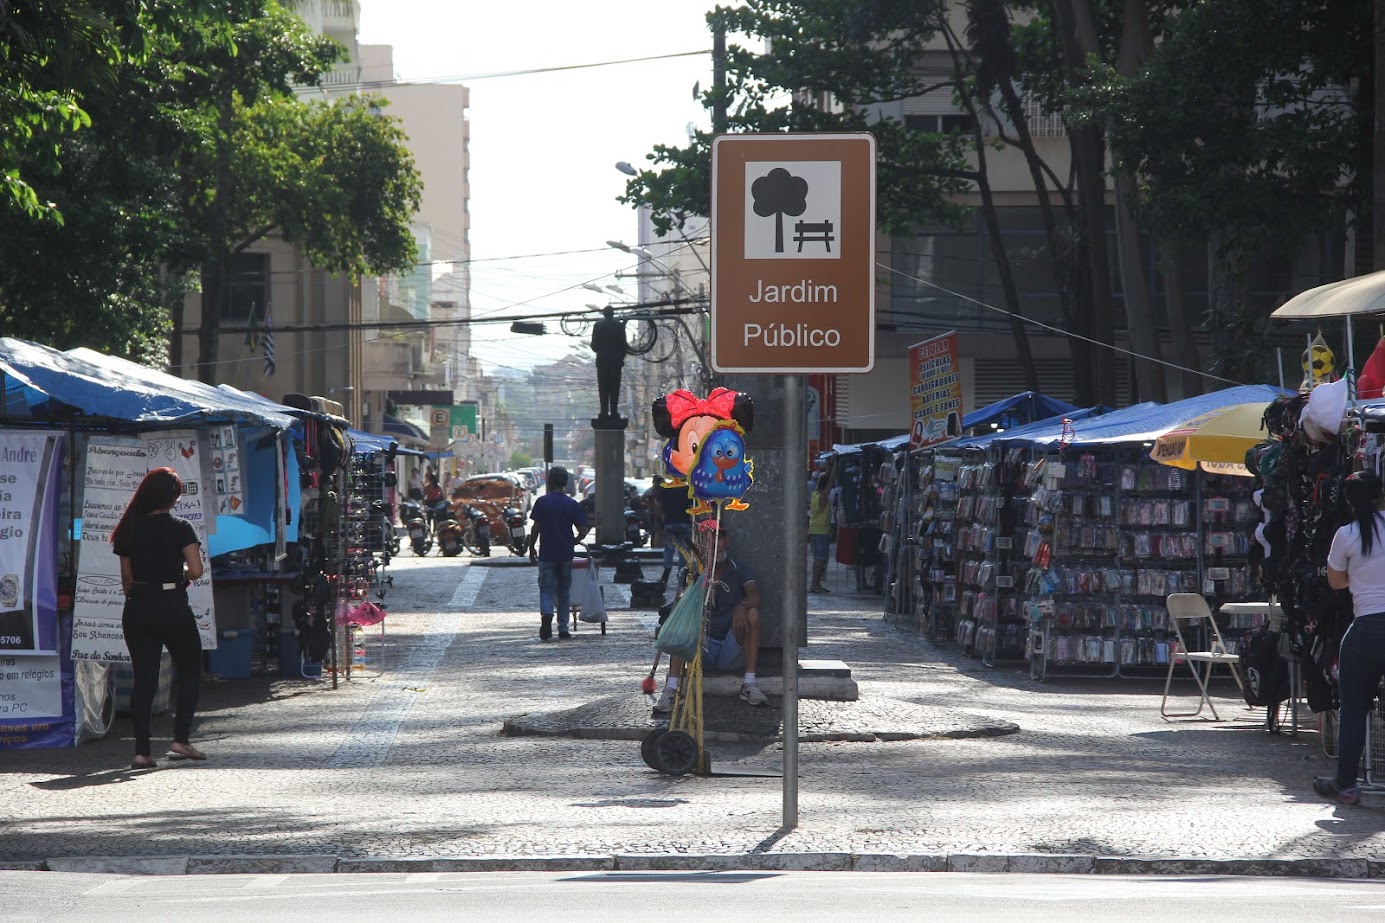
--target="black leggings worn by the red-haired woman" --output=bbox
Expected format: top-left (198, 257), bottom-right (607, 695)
top-left (120, 590), bottom-right (202, 757)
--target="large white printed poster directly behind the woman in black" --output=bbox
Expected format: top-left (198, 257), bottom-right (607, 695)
top-left (72, 430), bottom-right (216, 662)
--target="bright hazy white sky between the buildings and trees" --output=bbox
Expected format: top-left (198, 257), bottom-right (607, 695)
top-left (359, 0), bottom-right (715, 367)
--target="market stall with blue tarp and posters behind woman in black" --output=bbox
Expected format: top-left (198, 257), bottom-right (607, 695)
top-left (0, 338), bottom-right (292, 747)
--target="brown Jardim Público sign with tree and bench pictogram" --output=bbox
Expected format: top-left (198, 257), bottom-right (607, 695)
top-left (712, 133), bottom-right (875, 374)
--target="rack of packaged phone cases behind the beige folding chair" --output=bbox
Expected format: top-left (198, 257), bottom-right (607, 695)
top-left (1025, 448), bottom-right (1265, 679)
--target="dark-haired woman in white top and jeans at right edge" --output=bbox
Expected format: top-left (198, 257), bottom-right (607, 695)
top-left (1313, 471), bottom-right (1385, 804)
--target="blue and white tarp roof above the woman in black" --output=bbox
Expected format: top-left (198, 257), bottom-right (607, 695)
top-left (0, 337), bottom-right (294, 430)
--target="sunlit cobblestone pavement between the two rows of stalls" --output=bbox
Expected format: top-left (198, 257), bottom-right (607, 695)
top-left (0, 553), bottom-right (1385, 874)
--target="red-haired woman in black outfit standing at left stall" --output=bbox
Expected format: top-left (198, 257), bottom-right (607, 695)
top-left (111, 468), bottom-right (206, 769)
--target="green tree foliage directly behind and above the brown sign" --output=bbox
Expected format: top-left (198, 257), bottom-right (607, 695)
top-left (620, 0), bottom-right (968, 233)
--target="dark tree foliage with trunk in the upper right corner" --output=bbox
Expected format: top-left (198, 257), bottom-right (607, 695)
top-left (1068, 0), bottom-right (1373, 380)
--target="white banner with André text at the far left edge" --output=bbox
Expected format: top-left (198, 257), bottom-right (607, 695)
top-left (0, 430), bottom-right (62, 654)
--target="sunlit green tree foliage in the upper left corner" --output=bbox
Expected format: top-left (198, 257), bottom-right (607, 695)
top-left (0, 0), bottom-right (421, 374)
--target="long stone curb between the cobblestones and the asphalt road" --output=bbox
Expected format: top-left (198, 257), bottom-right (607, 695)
top-left (27, 852), bottom-right (1385, 879)
